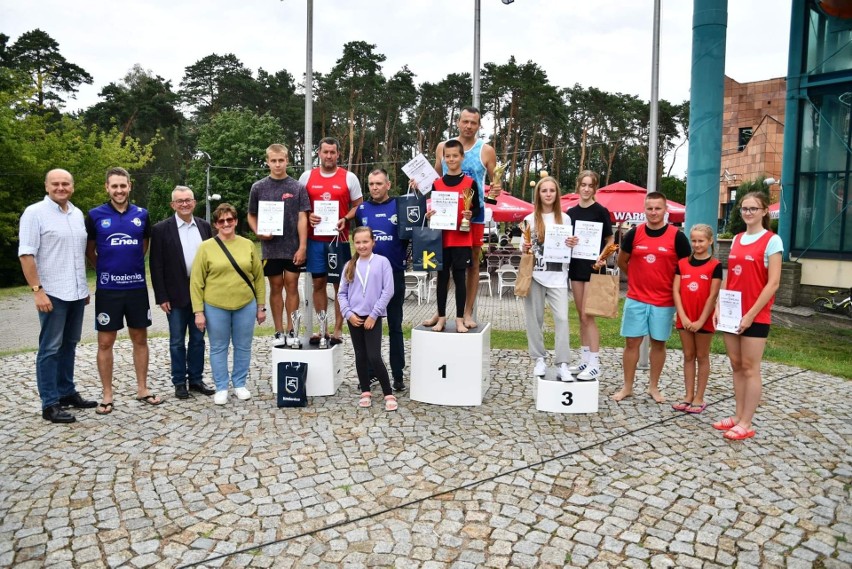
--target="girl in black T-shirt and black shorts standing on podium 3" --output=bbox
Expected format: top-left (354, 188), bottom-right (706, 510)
top-left (568, 170), bottom-right (614, 381)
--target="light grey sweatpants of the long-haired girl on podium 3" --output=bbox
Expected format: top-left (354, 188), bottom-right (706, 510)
top-left (524, 279), bottom-right (571, 364)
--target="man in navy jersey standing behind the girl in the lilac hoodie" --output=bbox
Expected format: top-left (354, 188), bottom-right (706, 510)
top-left (355, 168), bottom-right (408, 391)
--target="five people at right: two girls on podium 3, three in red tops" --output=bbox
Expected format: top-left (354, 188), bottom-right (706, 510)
top-left (523, 171), bottom-right (783, 440)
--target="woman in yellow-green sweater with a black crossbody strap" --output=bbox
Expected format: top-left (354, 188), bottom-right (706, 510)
top-left (189, 203), bottom-right (266, 405)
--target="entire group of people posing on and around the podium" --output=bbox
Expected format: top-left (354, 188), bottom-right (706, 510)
top-left (19, 107), bottom-right (782, 439)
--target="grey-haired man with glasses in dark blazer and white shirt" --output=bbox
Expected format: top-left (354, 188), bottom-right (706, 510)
top-left (149, 186), bottom-right (216, 399)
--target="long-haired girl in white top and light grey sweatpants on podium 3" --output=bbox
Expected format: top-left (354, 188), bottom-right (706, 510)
top-left (522, 176), bottom-right (578, 381)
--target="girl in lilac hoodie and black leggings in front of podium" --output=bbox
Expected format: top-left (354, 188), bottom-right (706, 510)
top-left (337, 226), bottom-right (397, 411)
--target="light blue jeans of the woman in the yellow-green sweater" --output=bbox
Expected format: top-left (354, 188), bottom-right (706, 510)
top-left (204, 300), bottom-right (257, 391)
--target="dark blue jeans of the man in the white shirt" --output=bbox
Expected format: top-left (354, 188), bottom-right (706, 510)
top-left (36, 296), bottom-right (86, 409)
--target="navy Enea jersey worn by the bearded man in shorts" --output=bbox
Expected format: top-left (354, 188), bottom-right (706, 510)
top-left (86, 202), bottom-right (151, 290)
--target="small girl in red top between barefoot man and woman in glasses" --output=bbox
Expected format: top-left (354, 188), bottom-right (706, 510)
top-left (672, 223), bottom-right (722, 413)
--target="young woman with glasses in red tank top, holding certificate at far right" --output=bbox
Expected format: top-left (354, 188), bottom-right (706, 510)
top-left (713, 192), bottom-right (784, 441)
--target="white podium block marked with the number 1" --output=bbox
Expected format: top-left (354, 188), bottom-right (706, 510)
top-left (409, 318), bottom-right (491, 407)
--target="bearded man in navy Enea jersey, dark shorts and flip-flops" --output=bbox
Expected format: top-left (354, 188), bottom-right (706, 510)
top-left (86, 168), bottom-right (163, 415)
